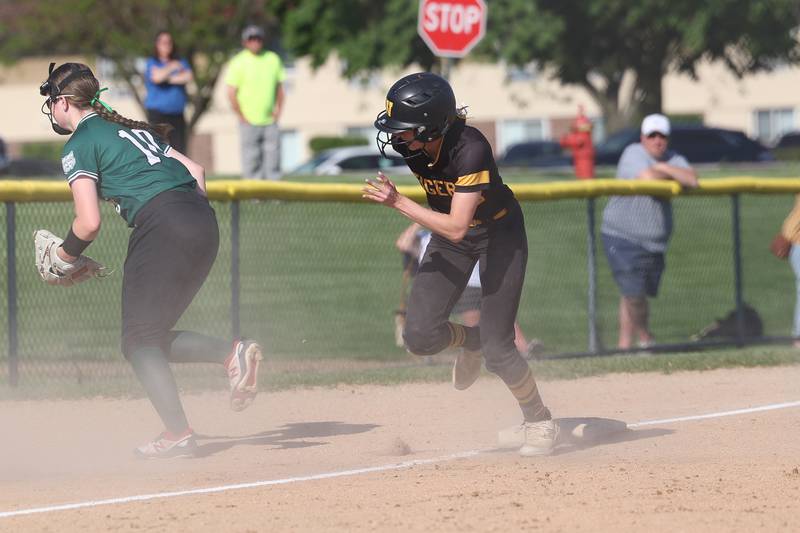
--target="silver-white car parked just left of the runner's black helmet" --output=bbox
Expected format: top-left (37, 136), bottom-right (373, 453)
top-left (289, 146), bottom-right (411, 176)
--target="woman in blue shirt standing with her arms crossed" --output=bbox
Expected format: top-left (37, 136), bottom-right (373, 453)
top-left (144, 31), bottom-right (193, 154)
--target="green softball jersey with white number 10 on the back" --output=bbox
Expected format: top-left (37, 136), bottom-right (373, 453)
top-left (61, 113), bottom-right (197, 226)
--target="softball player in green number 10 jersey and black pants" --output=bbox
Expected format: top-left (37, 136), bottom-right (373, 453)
top-left (40, 63), bottom-right (262, 458)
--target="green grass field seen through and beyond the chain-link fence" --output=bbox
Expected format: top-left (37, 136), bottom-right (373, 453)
top-left (0, 166), bottom-right (798, 392)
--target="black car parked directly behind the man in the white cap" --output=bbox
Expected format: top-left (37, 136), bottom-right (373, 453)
top-left (595, 126), bottom-right (775, 165)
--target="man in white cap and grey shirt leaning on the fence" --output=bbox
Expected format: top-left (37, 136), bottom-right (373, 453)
top-left (600, 114), bottom-right (697, 350)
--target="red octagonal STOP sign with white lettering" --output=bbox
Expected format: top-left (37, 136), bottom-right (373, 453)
top-left (417, 0), bottom-right (488, 57)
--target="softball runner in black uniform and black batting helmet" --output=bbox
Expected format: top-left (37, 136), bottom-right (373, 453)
top-left (363, 72), bottom-right (556, 455)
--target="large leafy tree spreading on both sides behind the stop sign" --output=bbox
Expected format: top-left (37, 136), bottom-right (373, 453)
top-left (271, 0), bottom-right (800, 131)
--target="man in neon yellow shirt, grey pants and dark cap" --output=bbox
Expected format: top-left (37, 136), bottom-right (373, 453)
top-left (225, 25), bottom-right (286, 180)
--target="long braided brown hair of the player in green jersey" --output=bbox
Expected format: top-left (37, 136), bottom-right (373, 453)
top-left (50, 63), bottom-right (172, 139)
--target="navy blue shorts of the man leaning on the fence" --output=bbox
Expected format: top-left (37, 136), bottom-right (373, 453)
top-left (602, 233), bottom-right (664, 298)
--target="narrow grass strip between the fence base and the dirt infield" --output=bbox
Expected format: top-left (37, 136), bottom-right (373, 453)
top-left (0, 346), bottom-right (800, 401)
